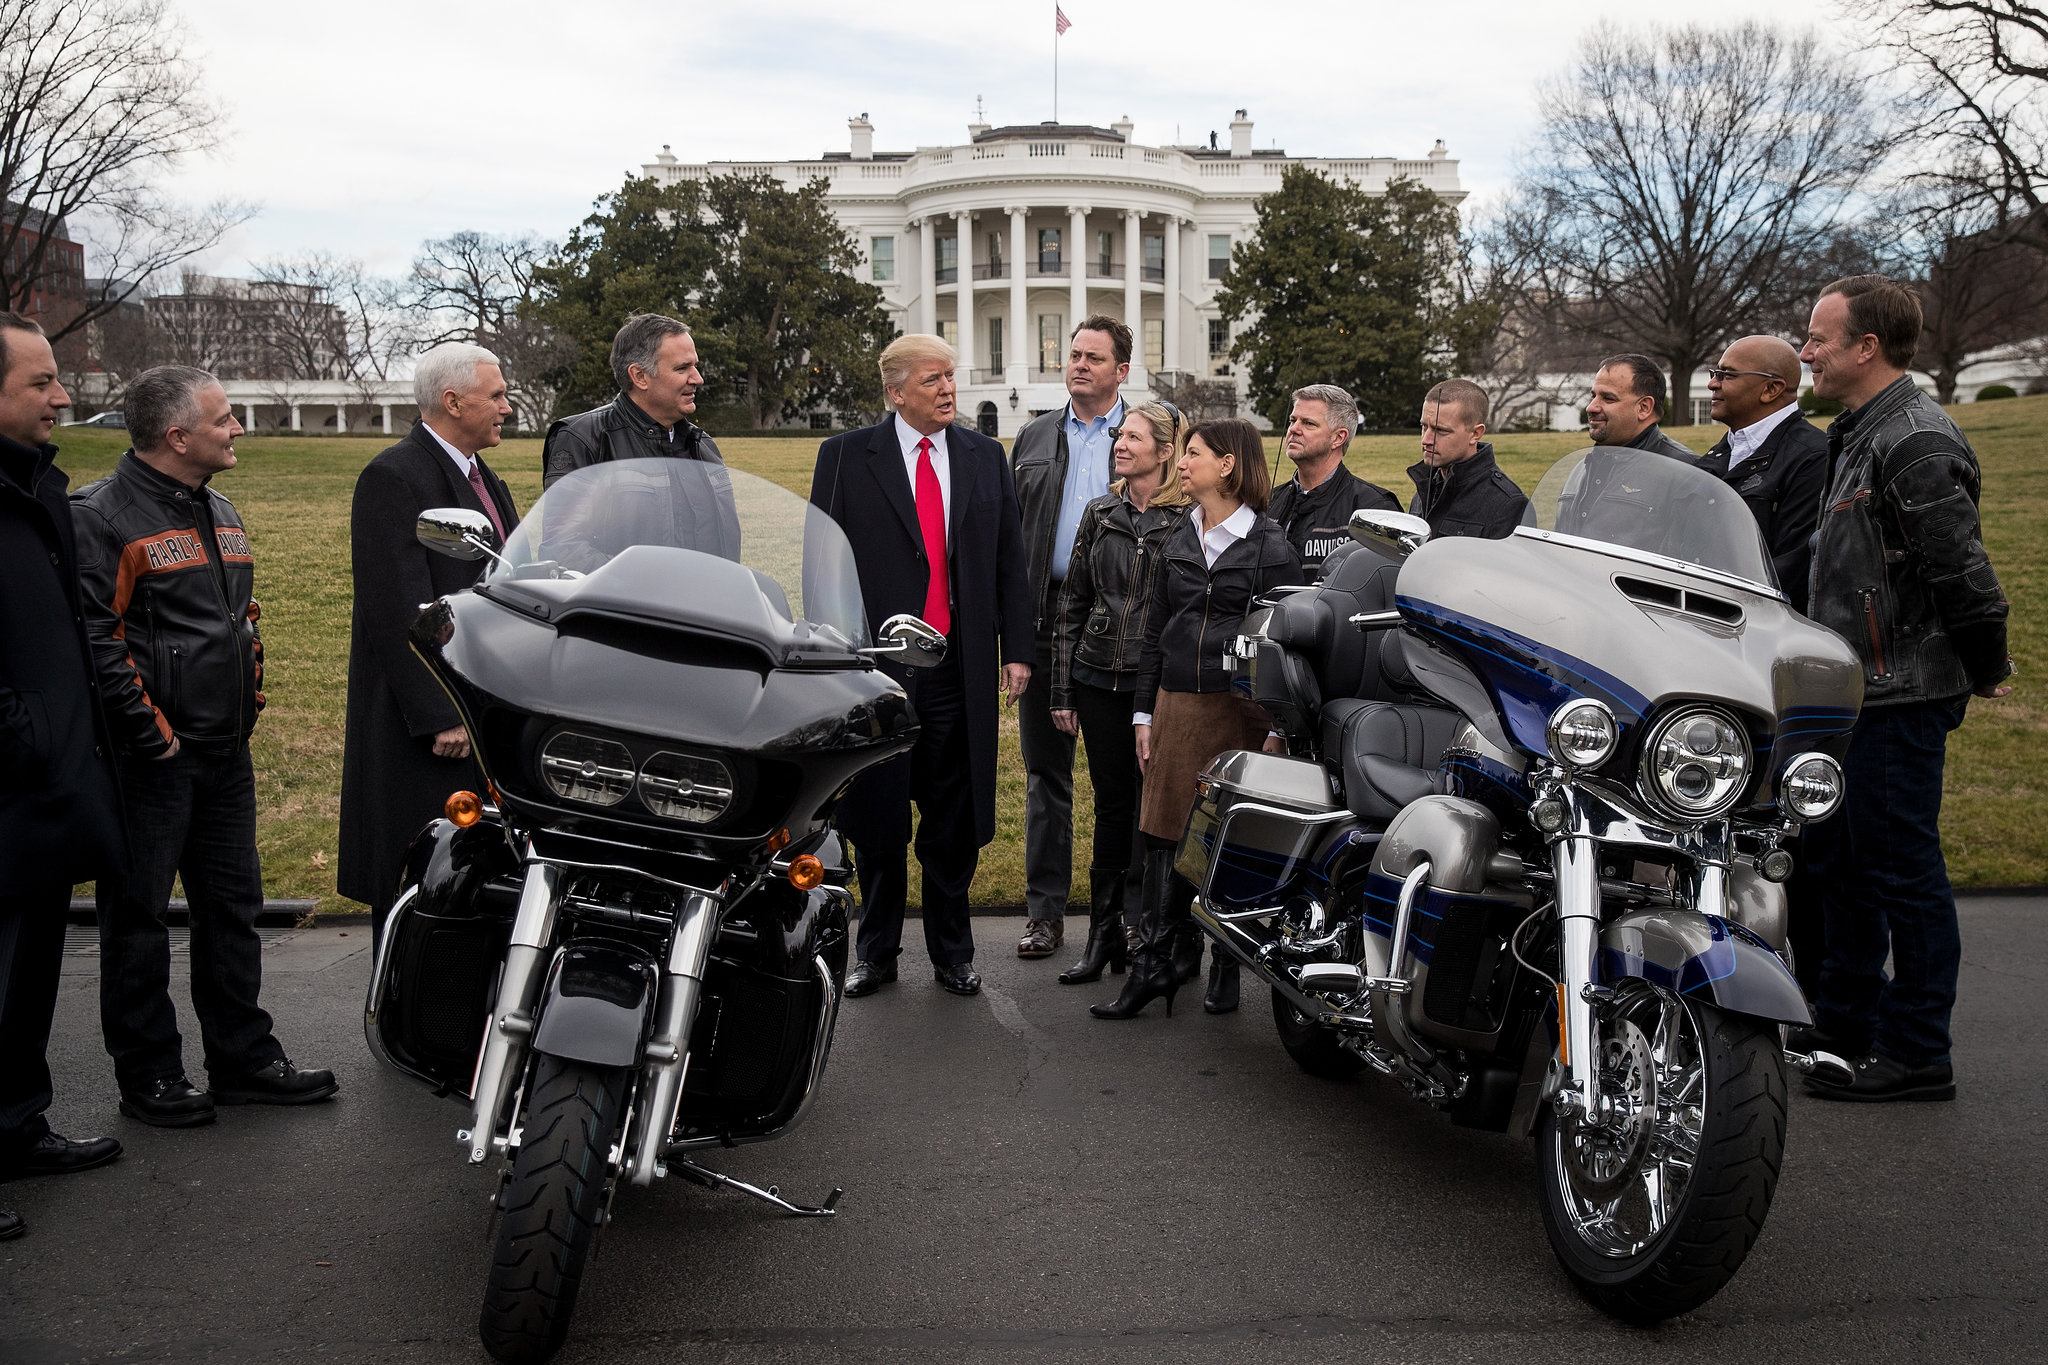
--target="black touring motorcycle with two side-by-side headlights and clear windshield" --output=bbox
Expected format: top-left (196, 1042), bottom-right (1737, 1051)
top-left (365, 460), bottom-right (944, 1361)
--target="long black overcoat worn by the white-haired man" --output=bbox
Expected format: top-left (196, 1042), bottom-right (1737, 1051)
top-left (338, 424), bottom-right (518, 909)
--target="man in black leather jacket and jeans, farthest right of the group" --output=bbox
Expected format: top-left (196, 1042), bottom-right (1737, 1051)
top-left (1788, 274), bottom-right (2013, 1101)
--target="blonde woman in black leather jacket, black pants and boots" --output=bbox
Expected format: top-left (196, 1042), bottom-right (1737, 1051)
top-left (1051, 403), bottom-right (1188, 986)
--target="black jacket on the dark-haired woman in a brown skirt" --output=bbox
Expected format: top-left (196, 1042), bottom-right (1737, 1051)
top-left (1133, 512), bottom-right (1303, 712)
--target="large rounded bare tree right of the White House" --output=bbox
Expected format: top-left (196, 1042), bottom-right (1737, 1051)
top-left (1505, 23), bottom-right (1880, 422)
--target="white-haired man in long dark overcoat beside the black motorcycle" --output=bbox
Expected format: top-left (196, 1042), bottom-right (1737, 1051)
top-left (340, 342), bottom-right (518, 937)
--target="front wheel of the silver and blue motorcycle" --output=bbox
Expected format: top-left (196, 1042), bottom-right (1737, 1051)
top-left (1536, 982), bottom-right (1786, 1322)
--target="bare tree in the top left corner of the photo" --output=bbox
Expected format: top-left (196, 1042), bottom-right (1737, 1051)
top-left (0, 0), bottom-right (248, 340)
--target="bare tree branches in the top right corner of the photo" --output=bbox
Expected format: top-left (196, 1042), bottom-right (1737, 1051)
top-left (1858, 0), bottom-right (2048, 252)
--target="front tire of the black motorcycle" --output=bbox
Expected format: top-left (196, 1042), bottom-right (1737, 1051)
top-left (477, 1056), bottom-right (629, 1365)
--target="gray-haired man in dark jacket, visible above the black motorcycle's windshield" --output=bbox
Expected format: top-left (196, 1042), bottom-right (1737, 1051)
top-left (541, 313), bottom-right (725, 489)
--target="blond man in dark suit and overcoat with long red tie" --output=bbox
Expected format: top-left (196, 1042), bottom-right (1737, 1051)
top-left (811, 336), bottom-right (1036, 997)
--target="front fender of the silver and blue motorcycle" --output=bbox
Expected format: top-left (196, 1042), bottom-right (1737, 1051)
top-left (1597, 911), bottom-right (1812, 1023)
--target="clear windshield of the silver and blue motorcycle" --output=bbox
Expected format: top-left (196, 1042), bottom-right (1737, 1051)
top-left (1520, 446), bottom-right (1778, 593)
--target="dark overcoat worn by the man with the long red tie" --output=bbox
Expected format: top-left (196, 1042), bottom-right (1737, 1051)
top-left (811, 417), bottom-right (1038, 843)
